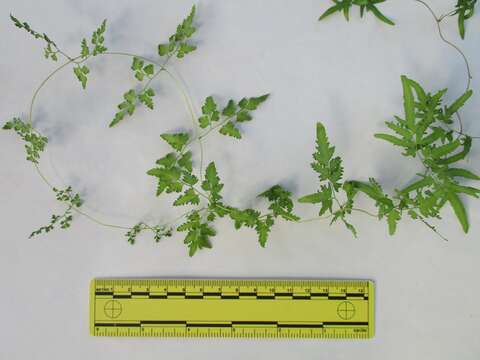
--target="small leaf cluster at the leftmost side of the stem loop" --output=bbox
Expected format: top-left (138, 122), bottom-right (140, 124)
top-left (3, 118), bottom-right (48, 164)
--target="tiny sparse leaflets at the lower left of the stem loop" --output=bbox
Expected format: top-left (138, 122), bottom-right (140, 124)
top-left (30, 186), bottom-right (83, 238)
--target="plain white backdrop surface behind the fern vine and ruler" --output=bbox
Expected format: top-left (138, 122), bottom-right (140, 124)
top-left (0, 0), bottom-right (480, 360)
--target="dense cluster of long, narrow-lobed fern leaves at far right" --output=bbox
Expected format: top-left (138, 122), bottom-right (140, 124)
top-left (375, 76), bottom-right (480, 232)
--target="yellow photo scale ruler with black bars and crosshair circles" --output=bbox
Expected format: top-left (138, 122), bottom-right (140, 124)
top-left (90, 279), bottom-right (374, 339)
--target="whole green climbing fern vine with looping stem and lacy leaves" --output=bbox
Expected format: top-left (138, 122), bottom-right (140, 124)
top-left (3, 0), bottom-right (480, 256)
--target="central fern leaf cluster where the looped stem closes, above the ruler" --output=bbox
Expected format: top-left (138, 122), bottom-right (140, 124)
top-left (147, 95), bottom-right (299, 256)
